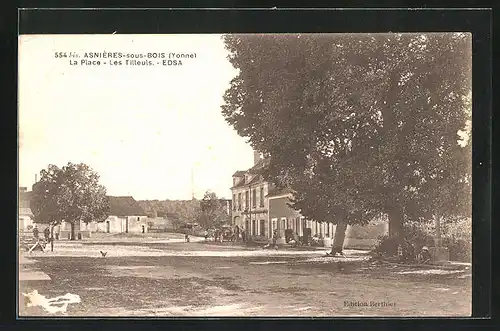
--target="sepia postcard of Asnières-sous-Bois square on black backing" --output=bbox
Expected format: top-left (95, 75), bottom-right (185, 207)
top-left (17, 32), bottom-right (472, 318)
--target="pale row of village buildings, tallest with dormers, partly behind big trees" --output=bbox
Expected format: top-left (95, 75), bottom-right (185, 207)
top-left (231, 152), bottom-right (388, 248)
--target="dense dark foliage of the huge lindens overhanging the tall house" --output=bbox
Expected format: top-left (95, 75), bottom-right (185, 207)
top-left (223, 33), bottom-right (471, 252)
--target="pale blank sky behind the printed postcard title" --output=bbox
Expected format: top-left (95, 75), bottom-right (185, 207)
top-left (18, 35), bottom-right (253, 200)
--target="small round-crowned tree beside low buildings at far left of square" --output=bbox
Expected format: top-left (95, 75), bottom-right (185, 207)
top-left (31, 163), bottom-right (109, 239)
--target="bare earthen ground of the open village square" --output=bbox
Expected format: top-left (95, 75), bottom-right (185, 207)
top-left (20, 239), bottom-right (471, 316)
